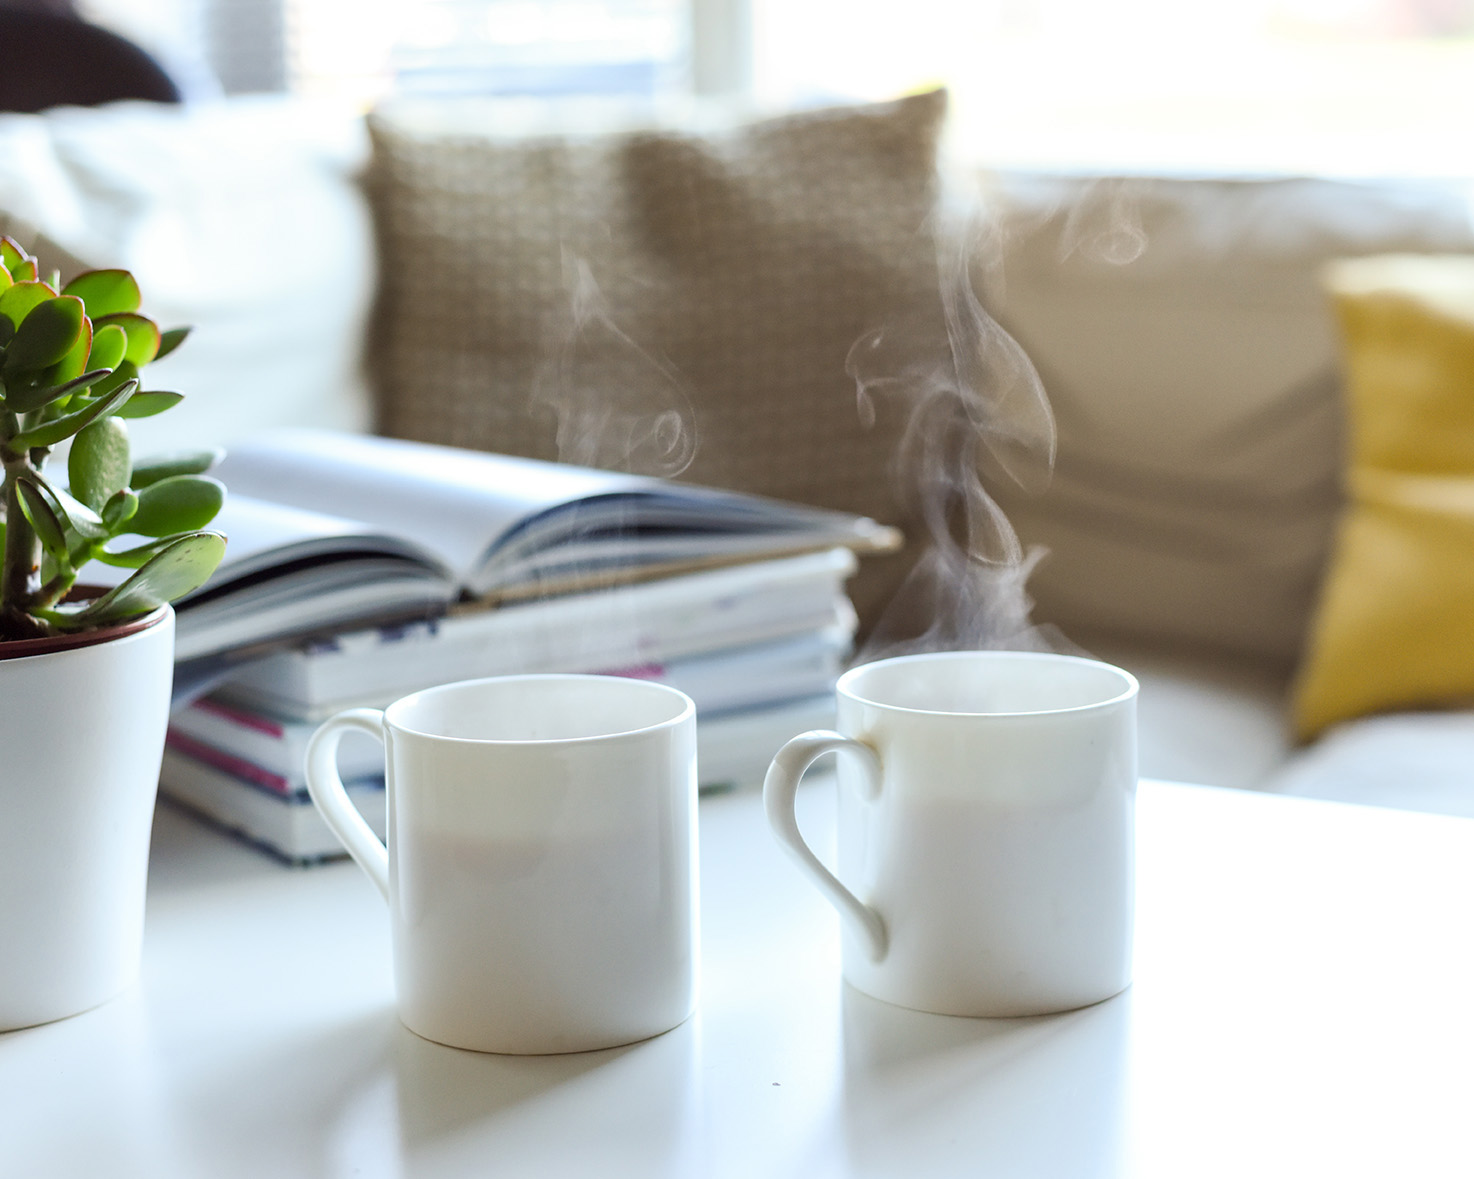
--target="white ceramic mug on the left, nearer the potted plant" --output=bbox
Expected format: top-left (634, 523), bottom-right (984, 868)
top-left (307, 675), bottom-right (697, 1054)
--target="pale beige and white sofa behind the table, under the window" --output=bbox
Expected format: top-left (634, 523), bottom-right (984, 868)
top-left (0, 100), bottom-right (1474, 815)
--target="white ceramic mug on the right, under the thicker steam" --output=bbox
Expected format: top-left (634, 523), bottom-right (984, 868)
top-left (764, 651), bottom-right (1136, 1015)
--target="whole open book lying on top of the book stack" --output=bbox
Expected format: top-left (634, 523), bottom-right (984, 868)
top-left (140, 430), bottom-right (901, 660)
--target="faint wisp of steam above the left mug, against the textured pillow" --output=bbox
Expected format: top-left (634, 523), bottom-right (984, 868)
top-left (532, 251), bottom-right (696, 477)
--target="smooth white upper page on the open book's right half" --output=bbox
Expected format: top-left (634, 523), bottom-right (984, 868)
top-left (214, 429), bottom-right (653, 584)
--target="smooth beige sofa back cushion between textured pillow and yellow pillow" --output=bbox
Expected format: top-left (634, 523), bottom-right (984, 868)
top-left (989, 175), bottom-right (1474, 669)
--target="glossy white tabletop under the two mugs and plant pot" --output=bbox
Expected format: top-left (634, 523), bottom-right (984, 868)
top-left (0, 781), bottom-right (1474, 1179)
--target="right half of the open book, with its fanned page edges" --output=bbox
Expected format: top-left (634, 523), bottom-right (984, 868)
top-left (207, 429), bottom-right (899, 601)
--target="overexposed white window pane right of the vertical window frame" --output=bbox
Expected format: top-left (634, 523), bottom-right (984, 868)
top-left (753, 0), bottom-right (1474, 175)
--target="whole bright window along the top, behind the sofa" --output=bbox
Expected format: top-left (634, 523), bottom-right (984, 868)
top-left (85, 0), bottom-right (1474, 175)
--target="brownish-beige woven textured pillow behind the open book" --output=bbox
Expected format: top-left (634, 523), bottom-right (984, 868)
top-left (370, 91), bottom-right (946, 618)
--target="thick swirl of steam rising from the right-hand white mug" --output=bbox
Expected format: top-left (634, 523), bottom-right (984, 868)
top-left (846, 204), bottom-right (1072, 662)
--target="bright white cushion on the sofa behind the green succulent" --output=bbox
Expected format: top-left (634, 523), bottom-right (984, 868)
top-left (0, 97), bottom-right (374, 454)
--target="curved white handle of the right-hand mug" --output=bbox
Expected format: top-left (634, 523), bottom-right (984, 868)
top-left (762, 730), bottom-right (889, 962)
